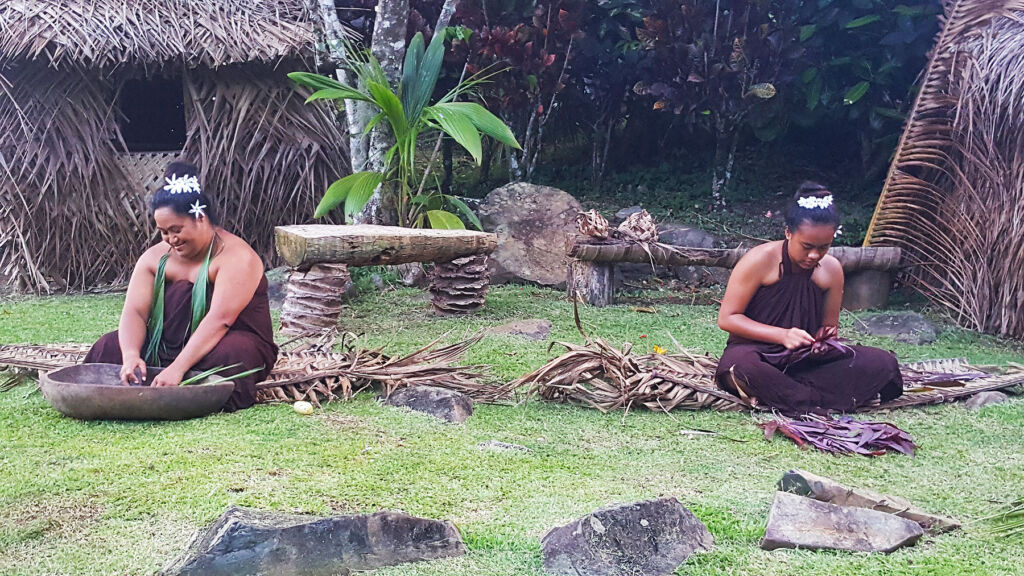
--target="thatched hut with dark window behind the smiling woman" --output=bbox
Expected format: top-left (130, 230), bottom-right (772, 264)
top-left (0, 0), bottom-right (348, 290)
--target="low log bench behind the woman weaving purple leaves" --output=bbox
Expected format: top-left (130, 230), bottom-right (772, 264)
top-left (565, 236), bottom-right (901, 310)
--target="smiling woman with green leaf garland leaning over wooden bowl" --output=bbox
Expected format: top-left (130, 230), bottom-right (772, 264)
top-left (85, 162), bottom-right (278, 411)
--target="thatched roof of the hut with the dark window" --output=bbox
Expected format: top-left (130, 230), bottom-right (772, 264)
top-left (0, 0), bottom-right (316, 68)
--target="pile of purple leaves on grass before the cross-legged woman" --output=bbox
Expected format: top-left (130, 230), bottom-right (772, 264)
top-left (758, 414), bottom-right (918, 456)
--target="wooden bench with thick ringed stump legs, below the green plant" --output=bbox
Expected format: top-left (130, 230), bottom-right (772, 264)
top-left (274, 224), bottom-right (498, 333)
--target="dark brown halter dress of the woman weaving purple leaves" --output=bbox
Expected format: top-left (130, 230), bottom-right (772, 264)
top-left (716, 241), bottom-right (903, 415)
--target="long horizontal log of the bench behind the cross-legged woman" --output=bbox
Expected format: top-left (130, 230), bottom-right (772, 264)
top-left (569, 242), bottom-right (902, 273)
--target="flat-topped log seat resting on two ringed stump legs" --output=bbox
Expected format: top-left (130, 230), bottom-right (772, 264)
top-left (274, 224), bottom-right (498, 270)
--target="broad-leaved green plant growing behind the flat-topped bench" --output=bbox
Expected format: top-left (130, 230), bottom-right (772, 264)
top-left (288, 30), bottom-right (520, 229)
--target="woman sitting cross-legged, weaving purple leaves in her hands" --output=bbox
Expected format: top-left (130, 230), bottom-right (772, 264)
top-left (716, 182), bottom-right (903, 415)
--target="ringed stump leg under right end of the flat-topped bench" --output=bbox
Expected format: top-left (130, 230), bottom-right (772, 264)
top-left (430, 254), bottom-right (490, 314)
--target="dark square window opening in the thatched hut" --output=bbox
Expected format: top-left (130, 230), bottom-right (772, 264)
top-left (118, 76), bottom-right (185, 152)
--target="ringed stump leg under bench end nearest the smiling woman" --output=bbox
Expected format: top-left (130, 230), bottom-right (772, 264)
top-left (281, 263), bottom-right (352, 336)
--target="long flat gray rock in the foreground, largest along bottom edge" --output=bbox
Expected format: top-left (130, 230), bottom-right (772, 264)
top-left (161, 507), bottom-right (466, 576)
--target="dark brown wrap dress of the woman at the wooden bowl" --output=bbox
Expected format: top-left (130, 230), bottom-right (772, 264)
top-left (85, 276), bottom-right (278, 412)
